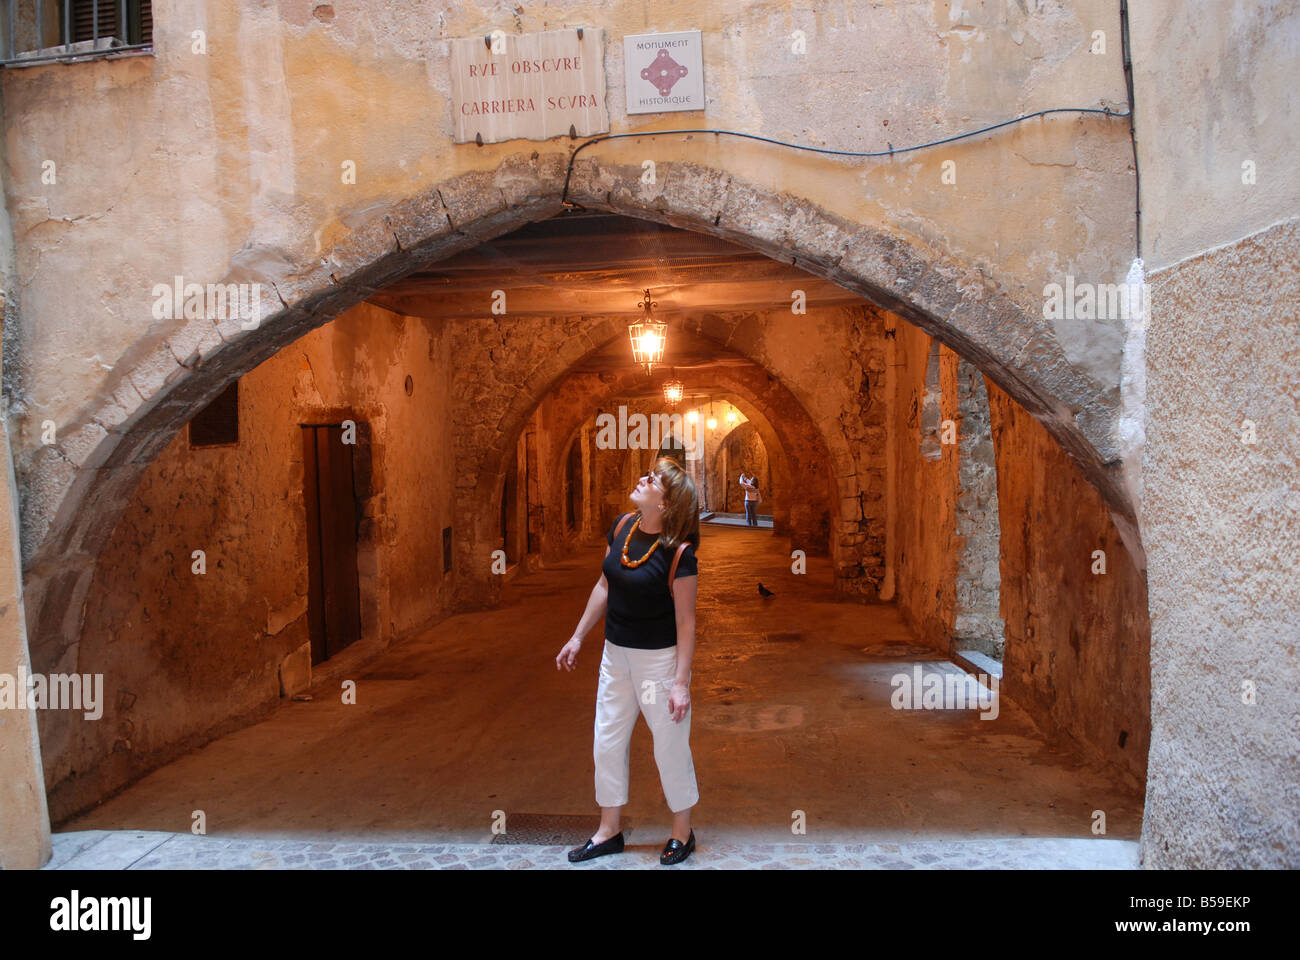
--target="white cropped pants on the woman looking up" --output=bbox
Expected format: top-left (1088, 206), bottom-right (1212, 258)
top-left (594, 640), bottom-right (699, 813)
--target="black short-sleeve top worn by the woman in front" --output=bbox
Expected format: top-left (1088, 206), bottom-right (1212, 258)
top-left (602, 514), bottom-right (699, 650)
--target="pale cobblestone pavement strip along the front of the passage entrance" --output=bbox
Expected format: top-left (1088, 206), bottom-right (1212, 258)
top-left (42, 830), bottom-right (1139, 870)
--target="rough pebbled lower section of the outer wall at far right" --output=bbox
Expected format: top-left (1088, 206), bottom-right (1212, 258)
top-left (1143, 220), bottom-right (1300, 868)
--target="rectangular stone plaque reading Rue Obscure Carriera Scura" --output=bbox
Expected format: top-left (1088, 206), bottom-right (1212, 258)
top-left (451, 29), bottom-right (610, 143)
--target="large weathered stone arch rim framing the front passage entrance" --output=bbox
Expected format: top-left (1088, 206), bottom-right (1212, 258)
top-left (18, 152), bottom-right (1140, 686)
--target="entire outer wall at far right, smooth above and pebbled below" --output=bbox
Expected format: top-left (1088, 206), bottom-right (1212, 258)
top-left (1131, 0), bottom-right (1300, 868)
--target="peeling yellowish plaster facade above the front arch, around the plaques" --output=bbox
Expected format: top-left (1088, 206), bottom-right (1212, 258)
top-left (0, 0), bottom-right (1132, 580)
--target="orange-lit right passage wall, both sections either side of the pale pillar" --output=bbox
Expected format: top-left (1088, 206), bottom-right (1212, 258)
top-left (892, 324), bottom-right (1149, 790)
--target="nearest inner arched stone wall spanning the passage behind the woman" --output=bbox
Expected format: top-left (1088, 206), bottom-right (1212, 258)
top-left (450, 306), bottom-right (885, 609)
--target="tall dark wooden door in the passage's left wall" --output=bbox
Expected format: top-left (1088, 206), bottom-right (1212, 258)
top-left (303, 425), bottom-right (361, 663)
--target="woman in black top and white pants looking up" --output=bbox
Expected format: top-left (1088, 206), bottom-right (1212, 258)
top-left (555, 458), bottom-right (699, 864)
